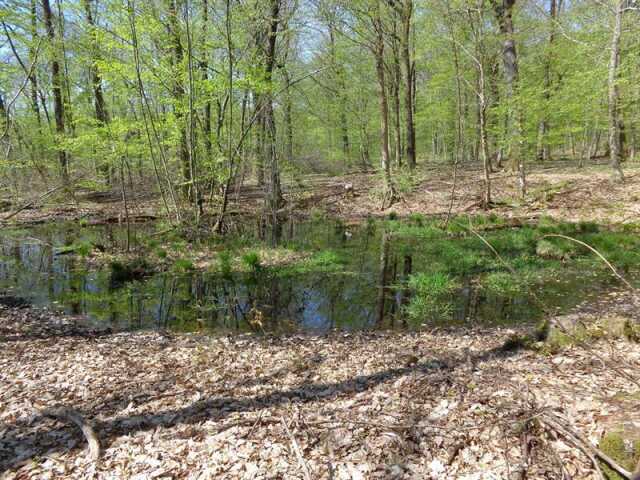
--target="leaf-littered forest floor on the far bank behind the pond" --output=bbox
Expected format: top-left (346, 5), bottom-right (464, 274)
top-left (0, 163), bottom-right (640, 224)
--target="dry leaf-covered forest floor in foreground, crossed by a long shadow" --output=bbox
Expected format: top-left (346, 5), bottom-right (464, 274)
top-left (0, 292), bottom-right (640, 480)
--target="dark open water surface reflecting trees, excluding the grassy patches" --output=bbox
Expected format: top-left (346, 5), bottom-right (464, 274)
top-left (0, 221), bottom-right (612, 332)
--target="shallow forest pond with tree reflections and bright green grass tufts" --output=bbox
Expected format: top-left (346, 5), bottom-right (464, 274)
top-left (0, 218), bottom-right (638, 333)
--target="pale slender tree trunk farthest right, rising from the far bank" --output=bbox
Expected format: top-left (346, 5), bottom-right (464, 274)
top-left (609, 0), bottom-right (626, 182)
